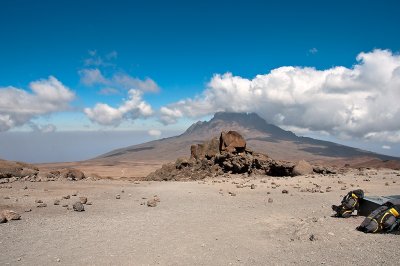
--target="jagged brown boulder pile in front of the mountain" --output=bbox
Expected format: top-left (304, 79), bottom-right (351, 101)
top-left (146, 131), bottom-right (334, 181)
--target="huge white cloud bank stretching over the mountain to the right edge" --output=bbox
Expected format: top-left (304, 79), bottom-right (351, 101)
top-left (160, 49), bottom-right (400, 142)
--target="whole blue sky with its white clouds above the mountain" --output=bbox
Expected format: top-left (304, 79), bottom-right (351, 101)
top-left (0, 0), bottom-right (400, 162)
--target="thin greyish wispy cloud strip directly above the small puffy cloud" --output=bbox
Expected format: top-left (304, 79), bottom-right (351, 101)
top-left (79, 68), bottom-right (160, 92)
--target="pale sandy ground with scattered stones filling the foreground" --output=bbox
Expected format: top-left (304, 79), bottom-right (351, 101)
top-left (0, 170), bottom-right (400, 265)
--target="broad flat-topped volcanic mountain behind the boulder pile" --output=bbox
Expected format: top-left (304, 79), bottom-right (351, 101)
top-left (93, 112), bottom-right (399, 166)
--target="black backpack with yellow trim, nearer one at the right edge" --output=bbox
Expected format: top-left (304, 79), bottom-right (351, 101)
top-left (357, 202), bottom-right (400, 233)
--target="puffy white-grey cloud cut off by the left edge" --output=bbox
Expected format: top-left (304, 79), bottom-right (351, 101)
top-left (0, 76), bottom-right (75, 131)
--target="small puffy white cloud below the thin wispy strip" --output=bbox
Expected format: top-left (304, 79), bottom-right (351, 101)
top-left (84, 89), bottom-right (153, 126)
